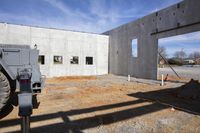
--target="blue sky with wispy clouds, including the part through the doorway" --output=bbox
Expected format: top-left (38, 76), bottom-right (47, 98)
top-left (0, 0), bottom-right (200, 56)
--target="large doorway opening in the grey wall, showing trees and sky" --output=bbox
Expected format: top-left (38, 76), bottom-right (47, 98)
top-left (157, 32), bottom-right (200, 81)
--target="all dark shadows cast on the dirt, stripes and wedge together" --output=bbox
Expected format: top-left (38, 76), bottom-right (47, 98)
top-left (0, 80), bottom-right (200, 133)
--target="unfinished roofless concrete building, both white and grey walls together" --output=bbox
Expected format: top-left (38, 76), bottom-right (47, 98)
top-left (0, 0), bottom-right (200, 79)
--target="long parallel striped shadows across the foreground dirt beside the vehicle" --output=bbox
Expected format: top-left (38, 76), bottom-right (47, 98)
top-left (0, 99), bottom-right (168, 133)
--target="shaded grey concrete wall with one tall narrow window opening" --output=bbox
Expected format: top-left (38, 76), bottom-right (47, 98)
top-left (104, 0), bottom-right (200, 79)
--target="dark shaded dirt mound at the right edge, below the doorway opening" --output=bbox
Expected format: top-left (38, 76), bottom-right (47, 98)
top-left (177, 79), bottom-right (200, 100)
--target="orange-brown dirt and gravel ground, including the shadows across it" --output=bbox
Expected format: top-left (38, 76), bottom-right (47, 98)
top-left (0, 75), bottom-right (200, 133)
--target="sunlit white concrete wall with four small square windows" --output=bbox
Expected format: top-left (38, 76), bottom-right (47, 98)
top-left (0, 23), bottom-right (109, 77)
